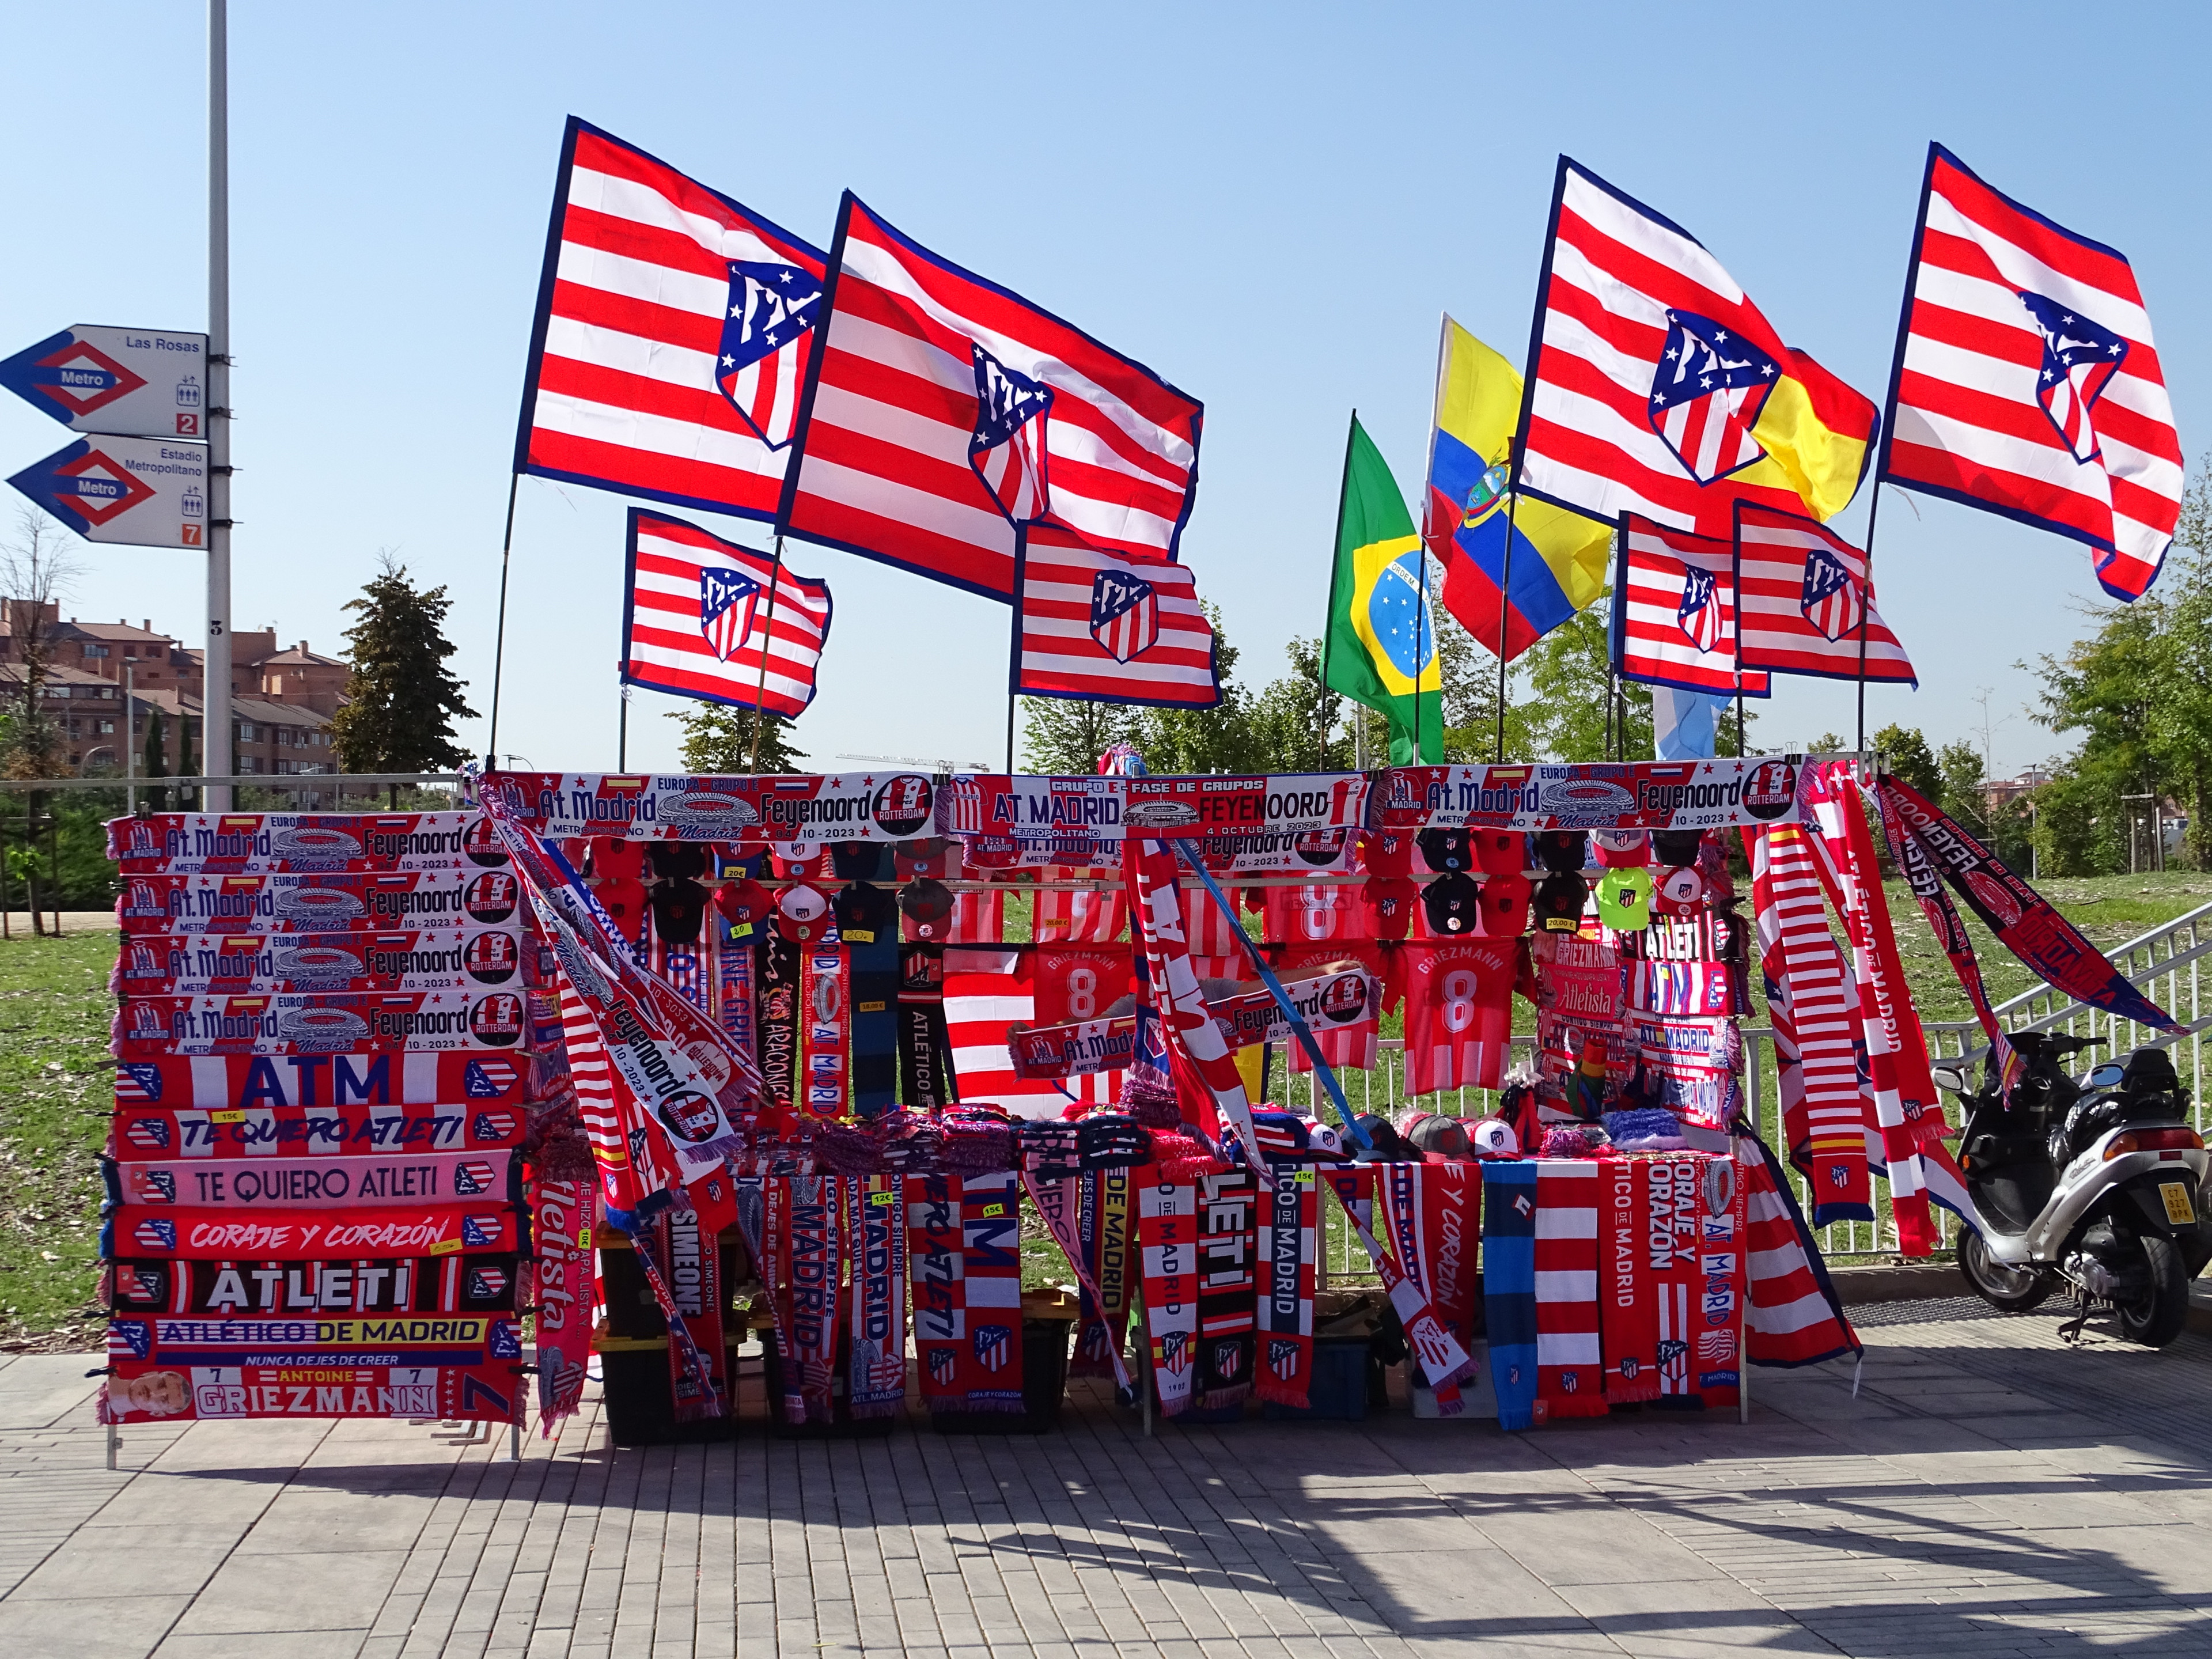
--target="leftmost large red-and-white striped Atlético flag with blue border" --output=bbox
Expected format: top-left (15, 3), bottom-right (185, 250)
top-left (516, 115), bottom-right (823, 520)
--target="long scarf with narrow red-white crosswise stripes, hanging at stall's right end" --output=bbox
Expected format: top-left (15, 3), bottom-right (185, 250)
top-left (1743, 823), bottom-right (1873, 1228)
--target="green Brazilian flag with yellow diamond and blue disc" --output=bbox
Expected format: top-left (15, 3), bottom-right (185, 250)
top-left (1320, 416), bottom-right (1445, 766)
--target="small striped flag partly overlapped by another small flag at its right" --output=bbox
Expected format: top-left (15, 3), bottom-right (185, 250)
top-left (1612, 513), bottom-right (1772, 697)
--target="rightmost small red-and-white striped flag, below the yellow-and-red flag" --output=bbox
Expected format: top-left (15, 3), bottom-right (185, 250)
top-left (1736, 502), bottom-right (1920, 685)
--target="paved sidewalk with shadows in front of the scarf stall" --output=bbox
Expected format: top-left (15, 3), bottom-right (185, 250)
top-left (0, 1301), bottom-right (2212, 1659)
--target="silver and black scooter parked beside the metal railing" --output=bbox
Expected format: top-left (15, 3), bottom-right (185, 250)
top-left (1931, 1031), bottom-right (2212, 1347)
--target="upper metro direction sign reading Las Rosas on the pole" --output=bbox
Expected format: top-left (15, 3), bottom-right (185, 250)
top-left (0, 323), bottom-right (208, 438)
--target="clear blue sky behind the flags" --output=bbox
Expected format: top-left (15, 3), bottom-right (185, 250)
top-left (0, 0), bottom-right (2212, 772)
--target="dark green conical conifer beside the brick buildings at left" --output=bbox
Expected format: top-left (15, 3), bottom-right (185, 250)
top-left (329, 553), bottom-right (476, 798)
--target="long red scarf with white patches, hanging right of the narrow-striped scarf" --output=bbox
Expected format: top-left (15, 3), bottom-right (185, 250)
top-left (1803, 766), bottom-right (1944, 1256)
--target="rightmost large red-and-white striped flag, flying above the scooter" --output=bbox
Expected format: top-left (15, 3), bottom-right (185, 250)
top-left (1883, 144), bottom-right (2183, 600)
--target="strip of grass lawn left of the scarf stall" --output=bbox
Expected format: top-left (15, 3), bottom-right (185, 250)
top-left (0, 929), bottom-right (115, 1349)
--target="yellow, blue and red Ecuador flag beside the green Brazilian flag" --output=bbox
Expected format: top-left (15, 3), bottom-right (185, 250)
top-left (1427, 316), bottom-right (1611, 661)
